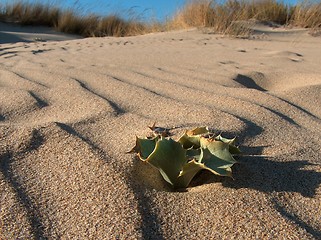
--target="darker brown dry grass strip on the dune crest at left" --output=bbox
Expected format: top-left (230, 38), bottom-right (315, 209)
top-left (0, 1), bottom-right (152, 37)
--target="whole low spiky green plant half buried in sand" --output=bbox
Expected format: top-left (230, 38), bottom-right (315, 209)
top-left (129, 124), bottom-right (241, 188)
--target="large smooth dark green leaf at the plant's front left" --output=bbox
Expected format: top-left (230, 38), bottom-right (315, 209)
top-left (146, 138), bottom-right (187, 187)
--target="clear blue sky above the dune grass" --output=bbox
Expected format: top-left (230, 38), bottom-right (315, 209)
top-left (4, 0), bottom-right (301, 21)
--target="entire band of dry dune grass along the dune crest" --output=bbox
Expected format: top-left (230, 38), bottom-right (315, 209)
top-left (0, 0), bottom-right (321, 37)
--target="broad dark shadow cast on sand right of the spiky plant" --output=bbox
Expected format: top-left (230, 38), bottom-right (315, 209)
top-left (223, 156), bottom-right (321, 198)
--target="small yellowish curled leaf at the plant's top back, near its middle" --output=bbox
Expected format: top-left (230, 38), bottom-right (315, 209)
top-left (178, 127), bottom-right (209, 149)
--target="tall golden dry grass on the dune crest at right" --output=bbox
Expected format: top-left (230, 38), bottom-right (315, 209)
top-left (169, 0), bottom-right (321, 35)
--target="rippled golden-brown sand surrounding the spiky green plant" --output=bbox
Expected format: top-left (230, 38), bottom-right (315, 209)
top-left (0, 25), bottom-right (321, 239)
